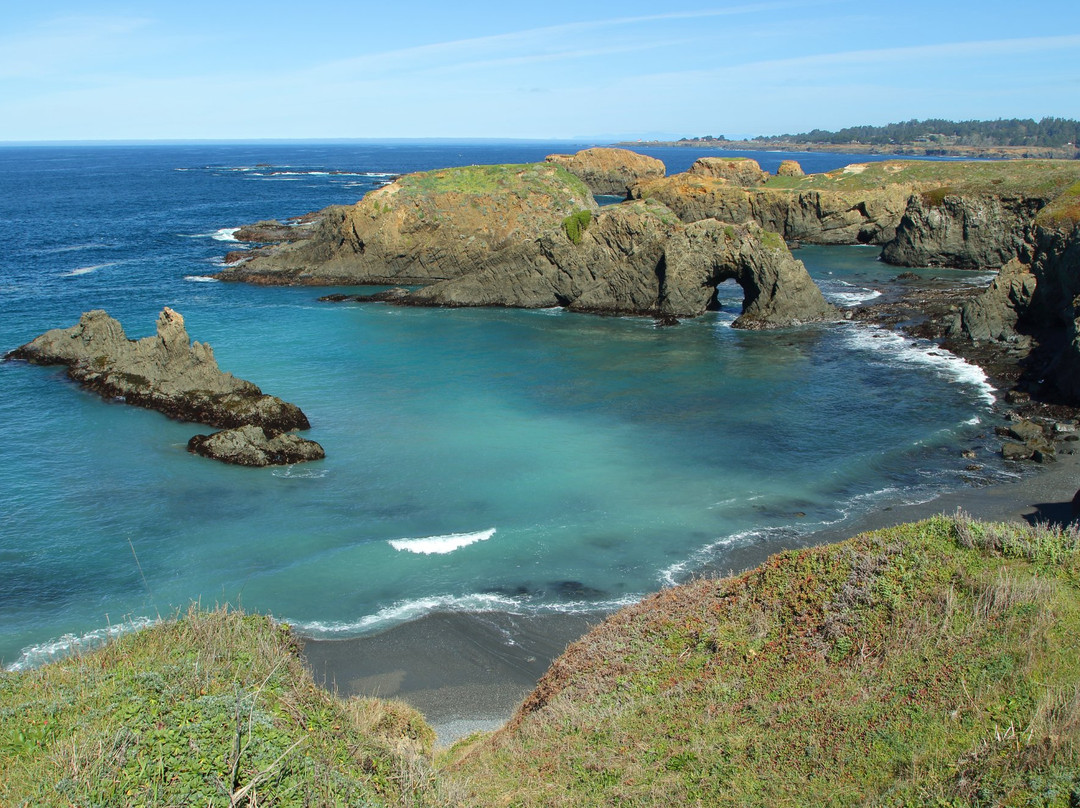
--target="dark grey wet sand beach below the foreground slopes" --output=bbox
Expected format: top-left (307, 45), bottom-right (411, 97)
top-left (305, 447), bottom-right (1080, 744)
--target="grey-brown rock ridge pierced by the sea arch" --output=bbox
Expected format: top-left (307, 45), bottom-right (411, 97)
top-left (345, 200), bottom-right (836, 328)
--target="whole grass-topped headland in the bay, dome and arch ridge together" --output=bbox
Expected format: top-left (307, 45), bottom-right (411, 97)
top-left (217, 150), bottom-right (838, 328)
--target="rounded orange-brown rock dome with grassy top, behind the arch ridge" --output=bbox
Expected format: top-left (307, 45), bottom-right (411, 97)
top-left (216, 163), bottom-right (597, 285)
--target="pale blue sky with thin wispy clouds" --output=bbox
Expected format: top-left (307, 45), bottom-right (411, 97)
top-left (0, 0), bottom-right (1080, 140)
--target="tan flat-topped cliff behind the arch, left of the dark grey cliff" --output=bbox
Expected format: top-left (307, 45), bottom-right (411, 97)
top-left (632, 174), bottom-right (910, 244)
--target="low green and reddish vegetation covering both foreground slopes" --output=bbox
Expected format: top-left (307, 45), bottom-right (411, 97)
top-left (0, 514), bottom-right (1080, 808)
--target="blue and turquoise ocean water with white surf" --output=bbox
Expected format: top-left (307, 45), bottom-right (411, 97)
top-left (0, 143), bottom-right (1004, 666)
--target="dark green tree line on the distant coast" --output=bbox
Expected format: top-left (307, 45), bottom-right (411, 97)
top-left (751, 118), bottom-right (1080, 146)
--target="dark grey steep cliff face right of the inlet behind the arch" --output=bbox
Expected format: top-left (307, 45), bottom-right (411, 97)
top-left (881, 189), bottom-right (1047, 269)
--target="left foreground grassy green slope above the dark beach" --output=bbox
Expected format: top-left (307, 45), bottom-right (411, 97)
top-left (0, 609), bottom-right (455, 808)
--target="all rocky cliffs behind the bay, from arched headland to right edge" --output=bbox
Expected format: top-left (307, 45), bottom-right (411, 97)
top-left (217, 149), bottom-right (1080, 416)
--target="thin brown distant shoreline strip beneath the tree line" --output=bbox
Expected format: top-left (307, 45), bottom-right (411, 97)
top-left (612, 138), bottom-right (1080, 160)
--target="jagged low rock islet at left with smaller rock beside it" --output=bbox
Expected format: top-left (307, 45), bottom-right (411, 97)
top-left (4, 308), bottom-right (323, 466)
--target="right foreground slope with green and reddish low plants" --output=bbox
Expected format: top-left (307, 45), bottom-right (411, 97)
top-left (451, 517), bottom-right (1080, 806)
